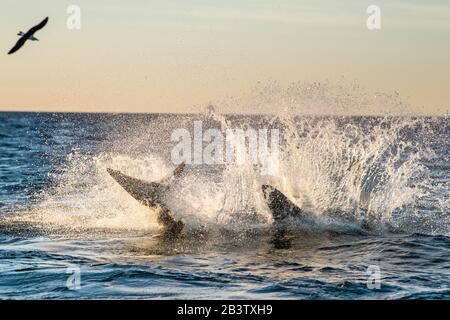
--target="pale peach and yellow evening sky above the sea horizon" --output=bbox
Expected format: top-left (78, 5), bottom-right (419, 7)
top-left (0, 0), bottom-right (450, 115)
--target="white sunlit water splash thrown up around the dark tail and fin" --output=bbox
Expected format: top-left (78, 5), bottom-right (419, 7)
top-left (1, 83), bottom-right (450, 238)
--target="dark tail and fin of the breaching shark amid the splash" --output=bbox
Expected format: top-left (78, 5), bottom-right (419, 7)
top-left (107, 164), bottom-right (311, 238)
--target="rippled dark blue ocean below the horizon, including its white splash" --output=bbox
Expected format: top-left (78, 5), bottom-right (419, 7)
top-left (0, 112), bottom-right (450, 299)
